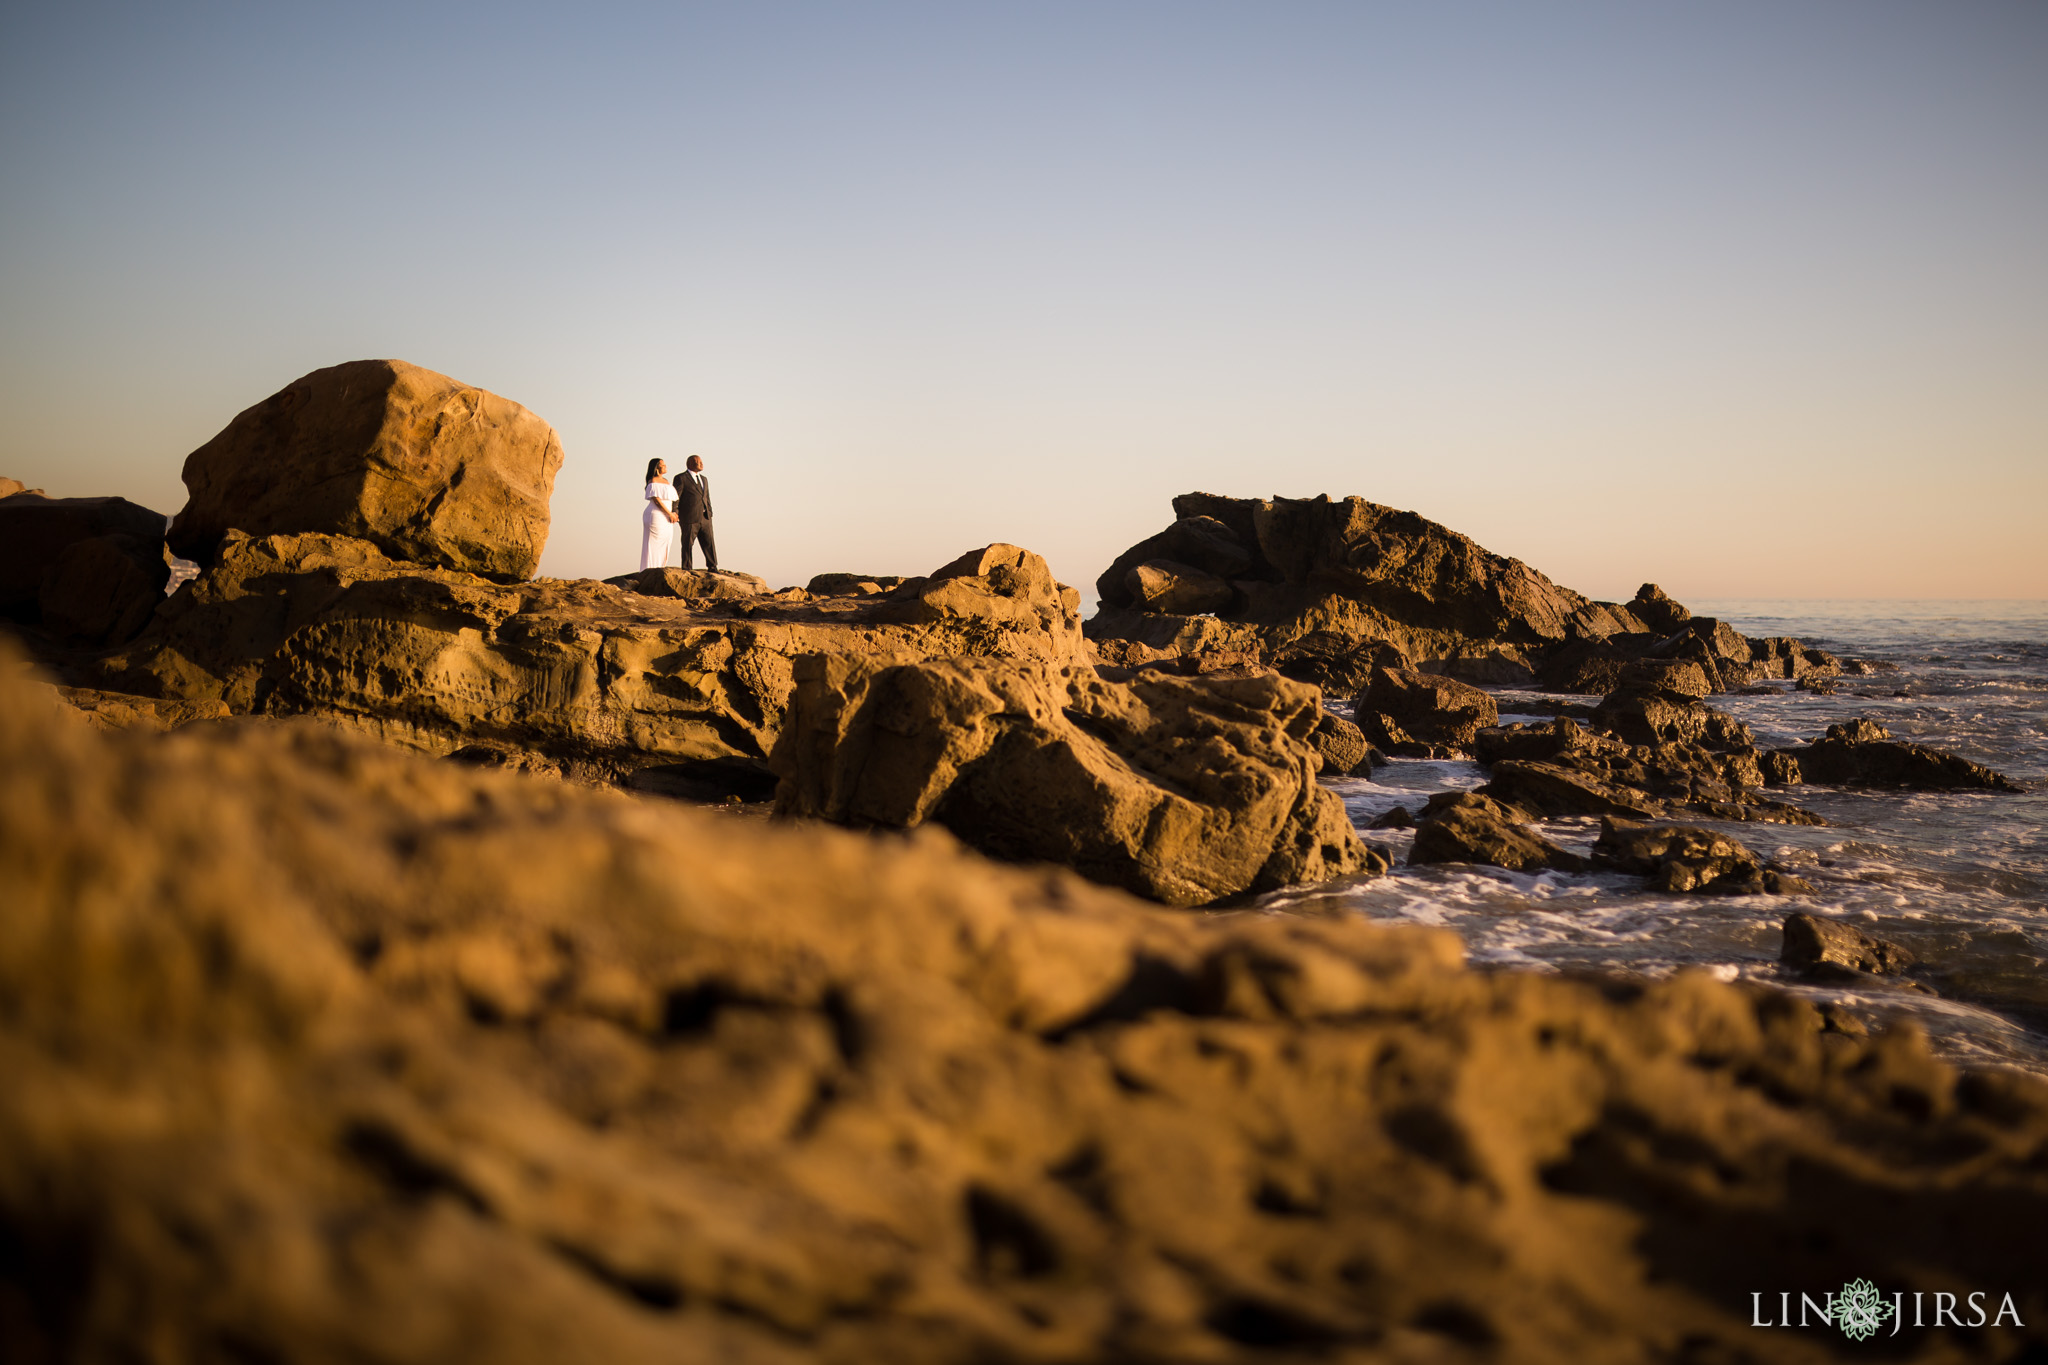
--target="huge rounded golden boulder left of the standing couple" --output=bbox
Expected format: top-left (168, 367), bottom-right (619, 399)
top-left (170, 360), bottom-right (561, 579)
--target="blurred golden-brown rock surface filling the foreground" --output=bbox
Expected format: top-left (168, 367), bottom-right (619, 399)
top-left (0, 642), bottom-right (2048, 1365)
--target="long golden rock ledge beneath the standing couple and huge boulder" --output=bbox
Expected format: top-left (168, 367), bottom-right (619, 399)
top-left (70, 532), bottom-right (1081, 792)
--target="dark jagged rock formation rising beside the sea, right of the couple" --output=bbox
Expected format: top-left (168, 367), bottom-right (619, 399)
top-left (1087, 493), bottom-right (1841, 696)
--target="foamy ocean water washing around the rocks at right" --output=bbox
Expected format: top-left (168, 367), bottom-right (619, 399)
top-left (1262, 602), bottom-right (2048, 1072)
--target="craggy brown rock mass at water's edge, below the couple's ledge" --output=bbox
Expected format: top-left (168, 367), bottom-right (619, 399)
top-left (770, 655), bottom-right (1384, 905)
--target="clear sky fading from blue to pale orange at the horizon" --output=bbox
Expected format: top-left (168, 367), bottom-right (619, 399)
top-left (0, 0), bottom-right (2048, 602)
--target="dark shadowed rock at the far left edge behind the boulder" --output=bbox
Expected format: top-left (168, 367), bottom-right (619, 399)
top-left (0, 493), bottom-right (170, 645)
